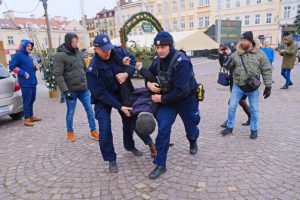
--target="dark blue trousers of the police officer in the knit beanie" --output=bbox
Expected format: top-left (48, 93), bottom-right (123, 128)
top-left (153, 97), bottom-right (200, 166)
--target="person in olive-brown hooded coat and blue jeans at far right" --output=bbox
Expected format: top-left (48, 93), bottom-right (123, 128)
top-left (279, 35), bottom-right (298, 89)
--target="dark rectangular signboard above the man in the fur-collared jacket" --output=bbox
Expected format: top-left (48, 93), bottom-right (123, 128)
top-left (215, 20), bottom-right (242, 45)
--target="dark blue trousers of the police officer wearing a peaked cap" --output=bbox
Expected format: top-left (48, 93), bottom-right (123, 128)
top-left (95, 104), bottom-right (152, 161)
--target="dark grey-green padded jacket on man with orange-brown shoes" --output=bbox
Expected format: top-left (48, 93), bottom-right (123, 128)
top-left (54, 44), bottom-right (87, 92)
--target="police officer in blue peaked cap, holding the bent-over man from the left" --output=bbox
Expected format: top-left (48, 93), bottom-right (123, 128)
top-left (87, 34), bottom-right (152, 173)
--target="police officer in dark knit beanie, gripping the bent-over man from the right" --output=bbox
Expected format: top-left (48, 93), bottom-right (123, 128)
top-left (146, 32), bottom-right (200, 179)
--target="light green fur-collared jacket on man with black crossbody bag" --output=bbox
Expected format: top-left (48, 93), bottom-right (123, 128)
top-left (226, 41), bottom-right (272, 86)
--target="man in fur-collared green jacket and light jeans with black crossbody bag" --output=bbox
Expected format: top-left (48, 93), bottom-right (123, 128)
top-left (221, 31), bottom-right (272, 139)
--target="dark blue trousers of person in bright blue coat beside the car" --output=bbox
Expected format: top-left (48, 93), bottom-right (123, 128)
top-left (21, 87), bottom-right (36, 119)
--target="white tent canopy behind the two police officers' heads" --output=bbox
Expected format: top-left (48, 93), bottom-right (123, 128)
top-left (111, 30), bottom-right (219, 51)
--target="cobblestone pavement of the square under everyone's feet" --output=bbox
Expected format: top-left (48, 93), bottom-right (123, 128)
top-left (0, 55), bottom-right (300, 200)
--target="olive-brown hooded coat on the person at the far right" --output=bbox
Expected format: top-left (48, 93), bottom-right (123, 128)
top-left (281, 35), bottom-right (298, 69)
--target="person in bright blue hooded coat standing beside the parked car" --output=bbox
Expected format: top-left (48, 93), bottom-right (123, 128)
top-left (9, 40), bottom-right (41, 126)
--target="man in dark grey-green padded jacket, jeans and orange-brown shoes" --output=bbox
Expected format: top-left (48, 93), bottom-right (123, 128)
top-left (54, 33), bottom-right (99, 142)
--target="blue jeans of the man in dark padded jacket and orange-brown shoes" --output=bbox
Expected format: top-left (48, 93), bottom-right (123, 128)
top-left (66, 90), bottom-right (97, 132)
